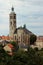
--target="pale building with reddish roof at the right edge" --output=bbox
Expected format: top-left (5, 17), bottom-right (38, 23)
top-left (30, 36), bottom-right (43, 50)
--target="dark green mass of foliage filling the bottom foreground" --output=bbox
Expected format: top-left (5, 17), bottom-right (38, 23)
top-left (0, 44), bottom-right (43, 65)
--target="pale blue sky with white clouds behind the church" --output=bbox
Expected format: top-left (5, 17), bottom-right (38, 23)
top-left (0, 0), bottom-right (43, 36)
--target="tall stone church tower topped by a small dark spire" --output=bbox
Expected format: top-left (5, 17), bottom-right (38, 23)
top-left (9, 7), bottom-right (16, 37)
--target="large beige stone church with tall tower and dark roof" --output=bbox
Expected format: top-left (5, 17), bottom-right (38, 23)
top-left (9, 7), bottom-right (33, 47)
